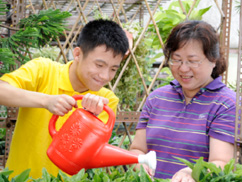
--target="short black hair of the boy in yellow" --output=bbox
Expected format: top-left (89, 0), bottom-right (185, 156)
top-left (77, 19), bottom-right (129, 57)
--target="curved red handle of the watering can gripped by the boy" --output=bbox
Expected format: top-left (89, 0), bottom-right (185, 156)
top-left (49, 95), bottom-right (115, 138)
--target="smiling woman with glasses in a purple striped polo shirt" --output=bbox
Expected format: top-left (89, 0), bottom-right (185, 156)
top-left (130, 21), bottom-right (236, 182)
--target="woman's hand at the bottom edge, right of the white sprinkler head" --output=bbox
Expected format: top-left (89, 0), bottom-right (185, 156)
top-left (171, 167), bottom-right (195, 182)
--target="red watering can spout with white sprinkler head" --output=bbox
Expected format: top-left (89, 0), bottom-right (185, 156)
top-left (89, 144), bottom-right (156, 171)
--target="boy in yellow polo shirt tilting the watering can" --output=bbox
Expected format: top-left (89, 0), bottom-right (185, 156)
top-left (0, 19), bottom-right (129, 178)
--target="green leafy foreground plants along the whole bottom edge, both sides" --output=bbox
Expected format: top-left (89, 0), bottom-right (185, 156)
top-left (0, 157), bottom-right (242, 182)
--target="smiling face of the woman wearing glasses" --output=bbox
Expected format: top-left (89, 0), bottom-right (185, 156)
top-left (170, 40), bottom-right (215, 97)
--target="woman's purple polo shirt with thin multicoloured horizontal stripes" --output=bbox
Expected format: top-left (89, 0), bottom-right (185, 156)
top-left (136, 77), bottom-right (236, 179)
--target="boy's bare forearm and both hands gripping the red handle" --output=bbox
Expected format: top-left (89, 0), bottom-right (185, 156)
top-left (0, 80), bottom-right (108, 116)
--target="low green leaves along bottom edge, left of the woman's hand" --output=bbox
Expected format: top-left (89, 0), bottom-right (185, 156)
top-left (0, 166), bottom-right (170, 182)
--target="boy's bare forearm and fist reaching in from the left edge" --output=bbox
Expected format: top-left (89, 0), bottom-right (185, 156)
top-left (0, 80), bottom-right (77, 116)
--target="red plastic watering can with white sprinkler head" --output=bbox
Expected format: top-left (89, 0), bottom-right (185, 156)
top-left (47, 95), bottom-right (156, 175)
